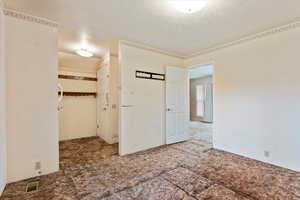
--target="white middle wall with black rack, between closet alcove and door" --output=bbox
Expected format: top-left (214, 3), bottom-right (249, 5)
top-left (119, 43), bottom-right (183, 155)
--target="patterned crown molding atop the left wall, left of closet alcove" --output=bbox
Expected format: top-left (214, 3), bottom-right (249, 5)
top-left (3, 8), bottom-right (58, 28)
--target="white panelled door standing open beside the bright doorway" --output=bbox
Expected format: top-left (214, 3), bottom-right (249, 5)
top-left (166, 67), bottom-right (189, 144)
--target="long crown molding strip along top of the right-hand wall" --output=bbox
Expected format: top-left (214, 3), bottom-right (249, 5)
top-left (189, 21), bottom-right (300, 58)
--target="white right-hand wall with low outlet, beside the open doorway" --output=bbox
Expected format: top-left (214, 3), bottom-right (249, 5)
top-left (185, 28), bottom-right (300, 171)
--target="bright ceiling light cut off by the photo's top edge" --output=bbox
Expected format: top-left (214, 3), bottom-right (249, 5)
top-left (170, 0), bottom-right (207, 14)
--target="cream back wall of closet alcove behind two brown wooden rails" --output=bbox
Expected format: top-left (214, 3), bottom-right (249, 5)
top-left (59, 71), bottom-right (97, 140)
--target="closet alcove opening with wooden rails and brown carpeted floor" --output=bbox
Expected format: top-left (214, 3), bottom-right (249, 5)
top-left (58, 52), bottom-right (119, 170)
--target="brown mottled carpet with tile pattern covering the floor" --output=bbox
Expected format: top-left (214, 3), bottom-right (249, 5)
top-left (1, 138), bottom-right (300, 200)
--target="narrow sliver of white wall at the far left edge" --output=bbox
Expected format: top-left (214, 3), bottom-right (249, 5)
top-left (0, 4), bottom-right (6, 195)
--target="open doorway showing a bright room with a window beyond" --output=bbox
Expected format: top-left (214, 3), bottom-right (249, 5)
top-left (189, 64), bottom-right (214, 143)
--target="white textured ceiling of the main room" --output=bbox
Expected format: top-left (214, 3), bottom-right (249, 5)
top-left (6, 0), bottom-right (300, 56)
